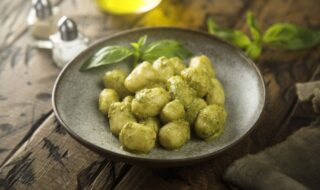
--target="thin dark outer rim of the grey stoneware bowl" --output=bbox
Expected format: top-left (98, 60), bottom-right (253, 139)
top-left (52, 27), bottom-right (266, 167)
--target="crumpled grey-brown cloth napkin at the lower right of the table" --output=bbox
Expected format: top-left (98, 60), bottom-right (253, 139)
top-left (224, 81), bottom-right (320, 190)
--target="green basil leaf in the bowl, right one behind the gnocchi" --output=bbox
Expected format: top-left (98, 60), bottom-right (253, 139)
top-left (141, 40), bottom-right (193, 62)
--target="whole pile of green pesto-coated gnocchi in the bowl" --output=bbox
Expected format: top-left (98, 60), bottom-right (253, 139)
top-left (99, 55), bottom-right (227, 153)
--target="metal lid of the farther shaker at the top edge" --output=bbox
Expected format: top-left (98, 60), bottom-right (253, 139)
top-left (32, 0), bottom-right (52, 19)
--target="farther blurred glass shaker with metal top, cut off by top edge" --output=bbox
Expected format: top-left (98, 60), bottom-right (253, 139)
top-left (27, 0), bottom-right (60, 39)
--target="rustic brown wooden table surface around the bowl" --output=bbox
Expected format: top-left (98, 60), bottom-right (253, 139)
top-left (0, 0), bottom-right (320, 189)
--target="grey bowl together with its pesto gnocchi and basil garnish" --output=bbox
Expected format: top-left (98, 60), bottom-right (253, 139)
top-left (53, 27), bottom-right (265, 167)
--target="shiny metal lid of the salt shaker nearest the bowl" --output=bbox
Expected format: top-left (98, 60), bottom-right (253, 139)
top-left (58, 16), bottom-right (78, 41)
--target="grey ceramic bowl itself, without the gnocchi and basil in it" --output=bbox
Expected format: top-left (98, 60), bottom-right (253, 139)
top-left (53, 28), bottom-right (265, 166)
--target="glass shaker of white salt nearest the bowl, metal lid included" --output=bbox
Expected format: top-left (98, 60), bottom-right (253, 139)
top-left (50, 16), bottom-right (88, 67)
